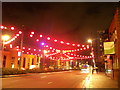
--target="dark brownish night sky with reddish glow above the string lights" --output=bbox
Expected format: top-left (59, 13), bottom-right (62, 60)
top-left (2, 2), bottom-right (117, 46)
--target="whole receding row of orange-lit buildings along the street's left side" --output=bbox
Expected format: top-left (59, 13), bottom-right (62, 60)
top-left (0, 49), bottom-right (70, 70)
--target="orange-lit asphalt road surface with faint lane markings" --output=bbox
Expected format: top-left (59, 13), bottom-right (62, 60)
top-left (2, 71), bottom-right (88, 88)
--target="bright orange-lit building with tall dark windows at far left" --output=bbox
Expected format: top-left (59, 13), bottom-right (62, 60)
top-left (1, 50), bottom-right (40, 69)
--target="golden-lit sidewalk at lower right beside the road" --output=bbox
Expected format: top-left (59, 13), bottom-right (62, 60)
top-left (86, 72), bottom-right (118, 88)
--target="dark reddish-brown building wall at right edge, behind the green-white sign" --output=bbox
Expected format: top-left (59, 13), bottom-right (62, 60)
top-left (109, 8), bottom-right (120, 80)
